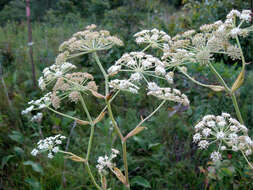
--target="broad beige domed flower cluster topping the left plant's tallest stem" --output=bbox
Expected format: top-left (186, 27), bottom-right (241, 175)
top-left (59, 24), bottom-right (123, 57)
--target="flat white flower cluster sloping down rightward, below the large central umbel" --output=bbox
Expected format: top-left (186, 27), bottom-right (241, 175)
top-left (147, 82), bottom-right (190, 106)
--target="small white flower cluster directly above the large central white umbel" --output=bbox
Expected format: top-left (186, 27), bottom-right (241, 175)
top-left (134, 28), bottom-right (171, 48)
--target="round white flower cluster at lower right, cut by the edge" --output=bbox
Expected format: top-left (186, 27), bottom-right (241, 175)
top-left (193, 113), bottom-right (253, 161)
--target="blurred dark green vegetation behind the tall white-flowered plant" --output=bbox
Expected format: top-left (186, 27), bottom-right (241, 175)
top-left (0, 0), bottom-right (253, 190)
